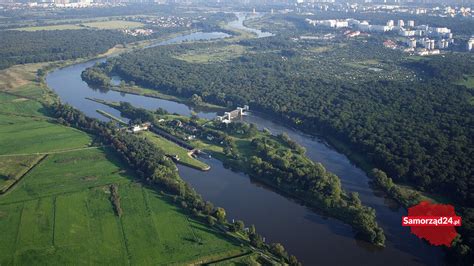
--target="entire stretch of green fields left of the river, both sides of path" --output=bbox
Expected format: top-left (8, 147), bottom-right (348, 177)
top-left (0, 62), bottom-right (248, 265)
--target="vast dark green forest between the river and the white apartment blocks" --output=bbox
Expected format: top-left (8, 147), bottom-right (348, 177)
top-left (85, 38), bottom-right (474, 262)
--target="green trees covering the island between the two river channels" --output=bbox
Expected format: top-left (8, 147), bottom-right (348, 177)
top-left (110, 102), bottom-right (385, 246)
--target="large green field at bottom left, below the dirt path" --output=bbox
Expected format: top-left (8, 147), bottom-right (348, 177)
top-left (0, 149), bottom-right (245, 265)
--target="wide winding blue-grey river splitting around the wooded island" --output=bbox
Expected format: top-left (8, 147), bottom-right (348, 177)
top-left (46, 14), bottom-right (443, 265)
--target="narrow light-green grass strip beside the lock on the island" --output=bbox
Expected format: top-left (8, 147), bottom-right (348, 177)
top-left (142, 132), bottom-right (209, 170)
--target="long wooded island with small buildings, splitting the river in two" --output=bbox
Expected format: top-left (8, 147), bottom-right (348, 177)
top-left (103, 99), bottom-right (385, 246)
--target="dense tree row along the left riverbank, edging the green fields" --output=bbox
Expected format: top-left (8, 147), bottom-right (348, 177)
top-left (51, 103), bottom-right (300, 266)
